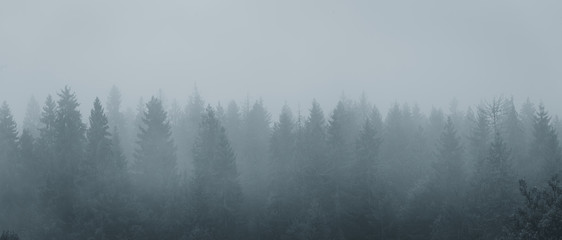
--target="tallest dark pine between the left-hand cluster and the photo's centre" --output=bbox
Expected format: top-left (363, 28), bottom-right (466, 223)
top-left (132, 97), bottom-right (178, 239)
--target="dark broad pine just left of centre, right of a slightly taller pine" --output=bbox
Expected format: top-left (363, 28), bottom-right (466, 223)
top-left (192, 106), bottom-right (242, 239)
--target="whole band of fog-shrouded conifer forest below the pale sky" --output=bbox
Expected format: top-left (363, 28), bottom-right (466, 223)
top-left (0, 87), bottom-right (562, 239)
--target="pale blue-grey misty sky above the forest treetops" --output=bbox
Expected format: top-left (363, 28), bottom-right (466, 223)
top-left (0, 0), bottom-right (562, 121)
